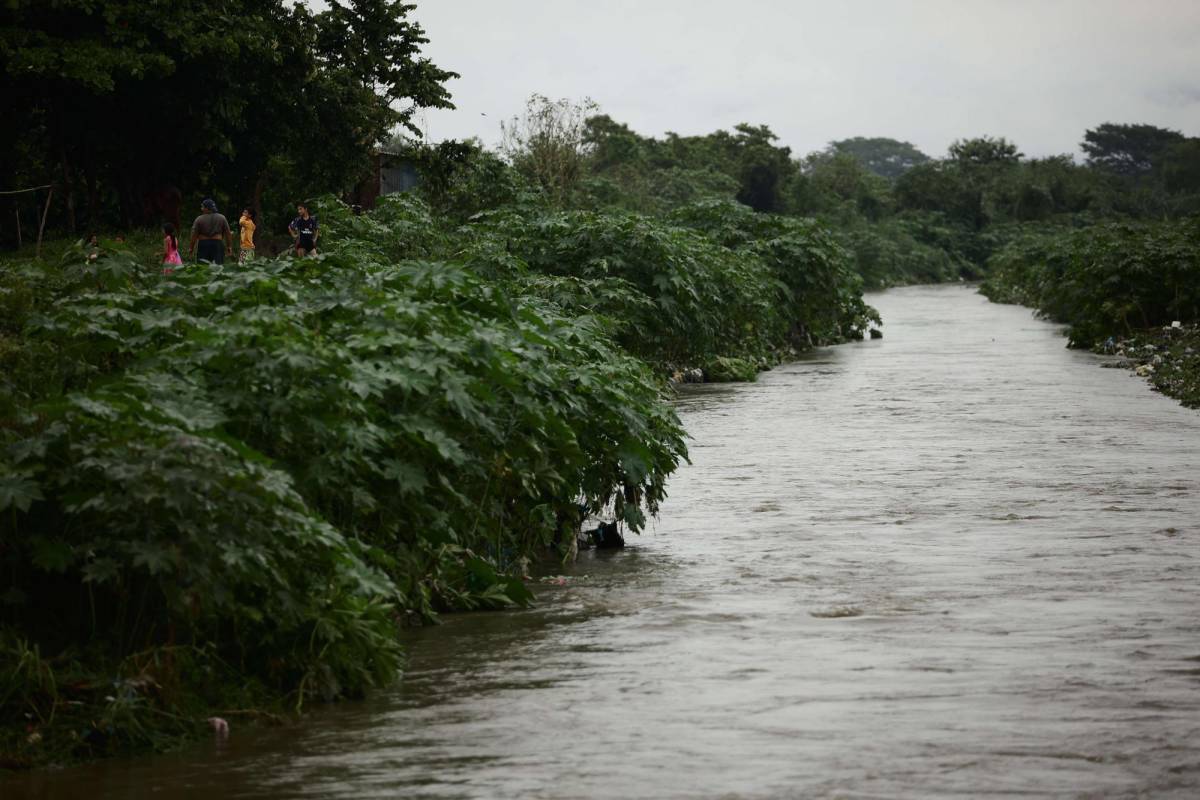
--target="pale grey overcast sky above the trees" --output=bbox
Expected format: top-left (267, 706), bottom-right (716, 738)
top-left (403, 0), bottom-right (1200, 156)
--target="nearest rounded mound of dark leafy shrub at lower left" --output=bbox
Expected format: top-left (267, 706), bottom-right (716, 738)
top-left (0, 381), bottom-right (398, 692)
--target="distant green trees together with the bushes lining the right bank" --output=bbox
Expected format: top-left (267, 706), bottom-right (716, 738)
top-left (482, 96), bottom-right (1200, 347)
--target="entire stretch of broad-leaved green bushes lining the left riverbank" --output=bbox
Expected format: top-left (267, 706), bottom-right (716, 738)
top-left (0, 189), bottom-right (878, 765)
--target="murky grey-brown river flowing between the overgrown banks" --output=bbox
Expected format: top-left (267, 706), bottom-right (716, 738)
top-left (9, 285), bottom-right (1200, 800)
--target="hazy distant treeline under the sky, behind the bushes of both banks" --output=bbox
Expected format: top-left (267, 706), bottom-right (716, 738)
top-left (487, 96), bottom-right (1200, 287)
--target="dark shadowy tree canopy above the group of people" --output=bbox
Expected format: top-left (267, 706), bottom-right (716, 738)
top-left (0, 0), bottom-right (455, 231)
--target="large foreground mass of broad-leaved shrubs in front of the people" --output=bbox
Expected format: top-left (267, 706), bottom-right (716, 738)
top-left (0, 198), bottom-right (685, 758)
